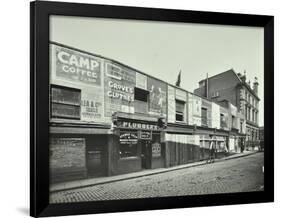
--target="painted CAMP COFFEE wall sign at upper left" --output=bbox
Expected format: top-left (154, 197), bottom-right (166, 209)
top-left (51, 45), bottom-right (101, 86)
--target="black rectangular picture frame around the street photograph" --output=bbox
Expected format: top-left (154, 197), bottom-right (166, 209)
top-left (30, 1), bottom-right (274, 217)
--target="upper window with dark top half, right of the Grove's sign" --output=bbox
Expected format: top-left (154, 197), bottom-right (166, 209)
top-left (134, 87), bottom-right (149, 113)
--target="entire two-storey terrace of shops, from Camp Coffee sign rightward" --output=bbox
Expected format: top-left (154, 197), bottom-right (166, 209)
top-left (50, 43), bottom-right (246, 183)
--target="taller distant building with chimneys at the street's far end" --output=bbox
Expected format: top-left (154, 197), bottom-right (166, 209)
top-left (194, 69), bottom-right (260, 147)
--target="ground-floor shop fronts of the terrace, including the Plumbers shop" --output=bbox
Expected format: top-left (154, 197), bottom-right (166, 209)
top-left (50, 113), bottom-right (244, 183)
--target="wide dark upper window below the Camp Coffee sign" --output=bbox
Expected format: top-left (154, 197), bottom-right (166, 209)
top-left (51, 85), bottom-right (81, 119)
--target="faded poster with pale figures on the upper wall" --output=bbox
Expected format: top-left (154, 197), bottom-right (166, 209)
top-left (147, 78), bottom-right (167, 116)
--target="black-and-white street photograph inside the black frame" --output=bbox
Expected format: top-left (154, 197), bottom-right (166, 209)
top-left (49, 15), bottom-right (267, 204)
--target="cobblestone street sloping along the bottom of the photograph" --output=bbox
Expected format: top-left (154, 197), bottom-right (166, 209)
top-left (50, 153), bottom-right (264, 203)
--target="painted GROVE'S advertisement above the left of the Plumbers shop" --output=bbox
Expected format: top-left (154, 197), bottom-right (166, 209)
top-left (104, 61), bottom-right (136, 117)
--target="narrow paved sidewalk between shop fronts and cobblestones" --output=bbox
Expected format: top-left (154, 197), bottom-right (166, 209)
top-left (50, 151), bottom-right (257, 192)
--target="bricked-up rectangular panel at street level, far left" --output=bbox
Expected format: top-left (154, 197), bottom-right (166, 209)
top-left (50, 138), bottom-right (86, 170)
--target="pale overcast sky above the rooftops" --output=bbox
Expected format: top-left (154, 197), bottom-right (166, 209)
top-left (50, 16), bottom-right (264, 126)
